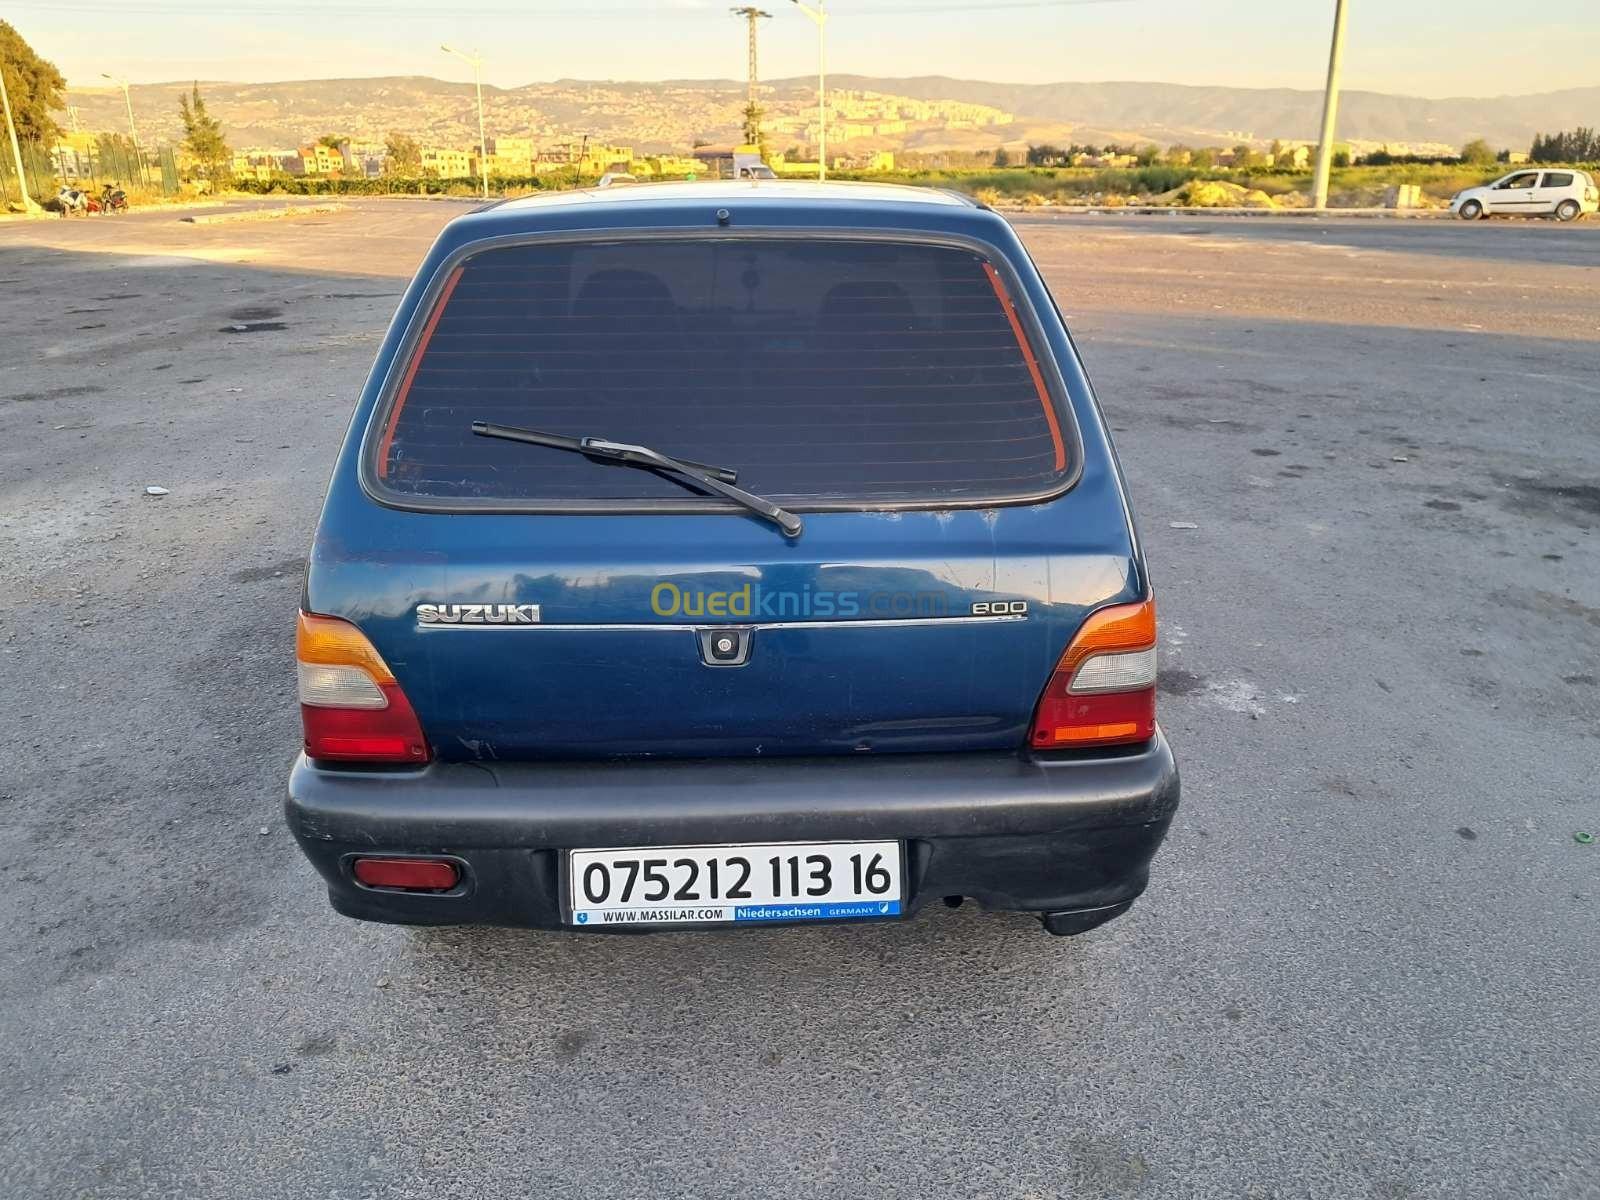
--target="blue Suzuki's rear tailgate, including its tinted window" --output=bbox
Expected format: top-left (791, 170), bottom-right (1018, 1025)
top-left (307, 224), bottom-right (1142, 758)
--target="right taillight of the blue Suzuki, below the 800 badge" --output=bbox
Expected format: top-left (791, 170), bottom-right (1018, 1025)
top-left (1029, 600), bottom-right (1155, 750)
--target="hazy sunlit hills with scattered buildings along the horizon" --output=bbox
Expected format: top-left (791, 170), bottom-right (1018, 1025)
top-left (56, 75), bottom-right (1600, 150)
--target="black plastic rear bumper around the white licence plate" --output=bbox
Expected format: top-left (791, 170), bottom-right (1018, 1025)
top-left (286, 734), bottom-right (1179, 933)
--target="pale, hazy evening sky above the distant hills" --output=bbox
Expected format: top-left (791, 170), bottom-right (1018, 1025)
top-left (5, 0), bottom-right (1600, 96)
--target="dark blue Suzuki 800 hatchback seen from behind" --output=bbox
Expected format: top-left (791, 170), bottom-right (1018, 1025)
top-left (288, 182), bottom-right (1178, 933)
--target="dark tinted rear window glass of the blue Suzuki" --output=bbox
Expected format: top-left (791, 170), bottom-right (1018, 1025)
top-left (371, 238), bottom-right (1069, 507)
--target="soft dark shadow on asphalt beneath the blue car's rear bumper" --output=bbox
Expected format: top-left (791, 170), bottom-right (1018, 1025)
top-left (390, 904), bottom-right (1109, 1069)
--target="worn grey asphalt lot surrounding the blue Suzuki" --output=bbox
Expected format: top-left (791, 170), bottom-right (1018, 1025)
top-left (0, 202), bottom-right (1600, 1200)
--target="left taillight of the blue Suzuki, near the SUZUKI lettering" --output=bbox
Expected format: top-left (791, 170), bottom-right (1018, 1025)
top-left (294, 613), bottom-right (432, 763)
